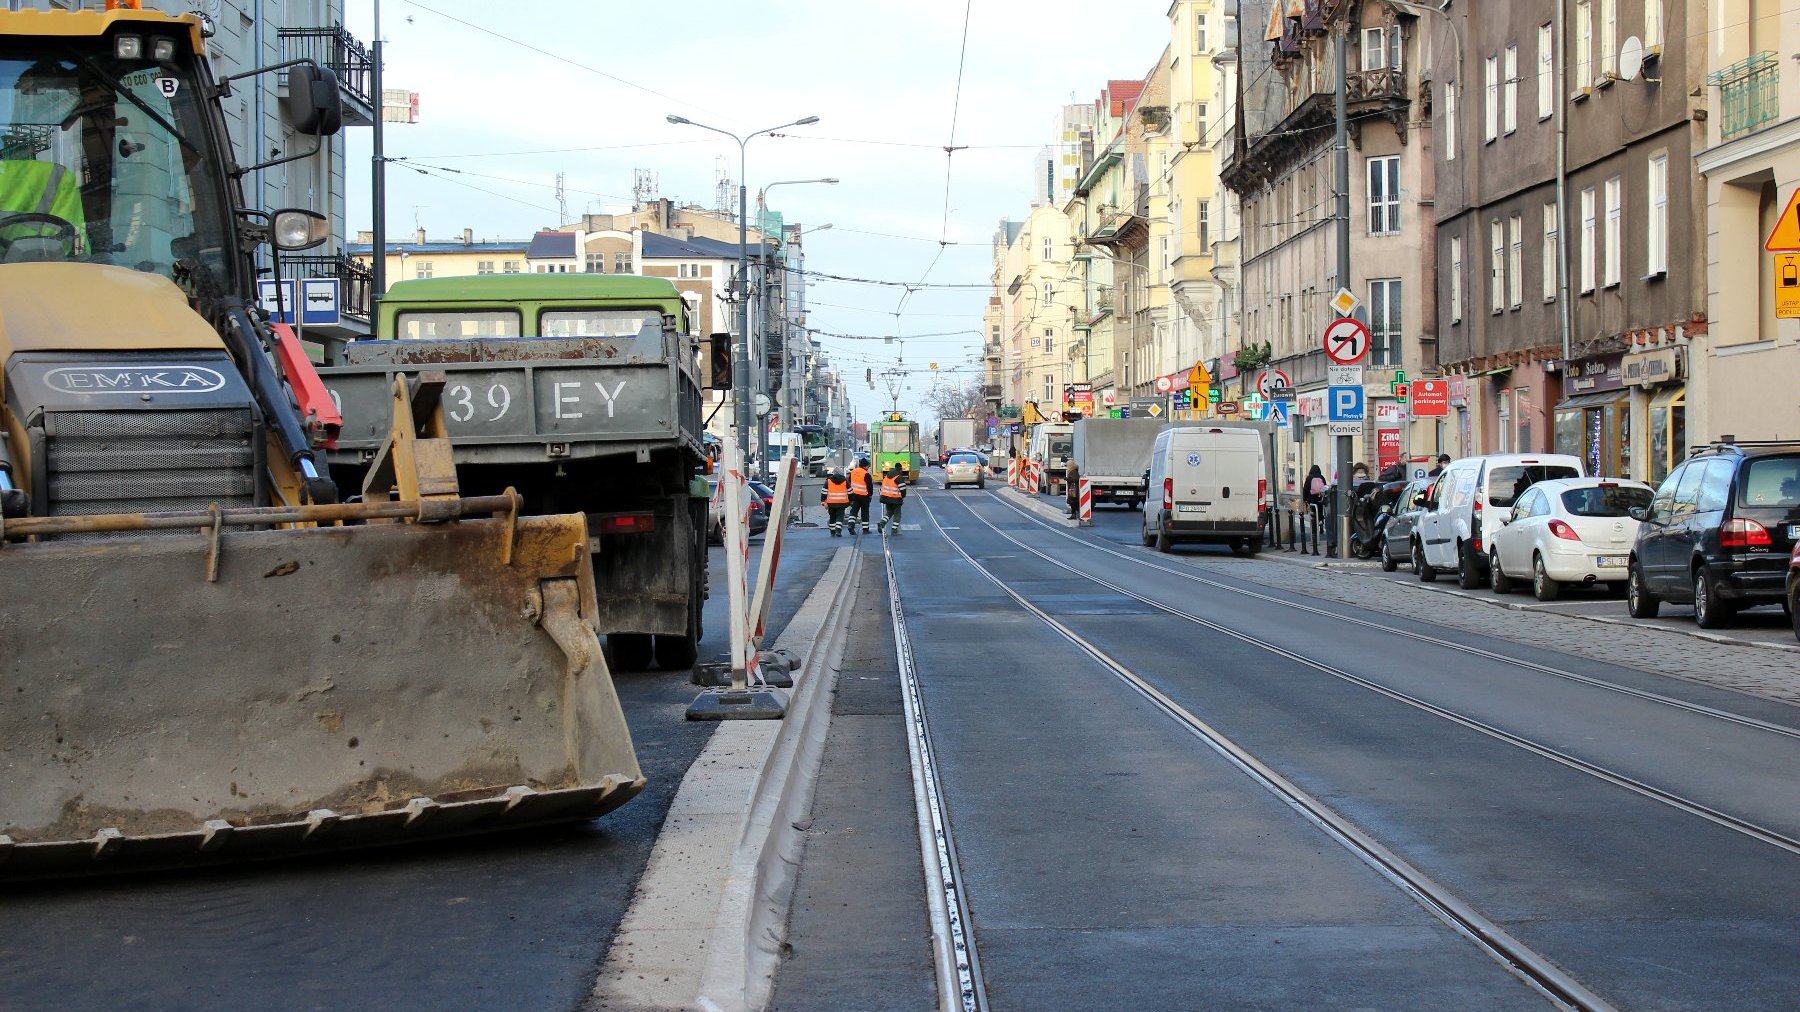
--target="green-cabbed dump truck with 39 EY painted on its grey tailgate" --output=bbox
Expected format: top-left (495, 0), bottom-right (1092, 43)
top-left (319, 274), bottom-right (711, 670)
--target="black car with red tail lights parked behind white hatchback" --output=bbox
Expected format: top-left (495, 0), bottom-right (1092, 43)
top-left (1627, 443), bottom-right (1800, 628)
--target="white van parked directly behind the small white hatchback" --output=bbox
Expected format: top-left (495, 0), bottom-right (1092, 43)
top-left (1413, 454), bottom-right (1588, 591)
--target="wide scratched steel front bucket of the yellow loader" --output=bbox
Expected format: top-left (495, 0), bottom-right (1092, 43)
top-left (0, 497), bottom-right (644, 879)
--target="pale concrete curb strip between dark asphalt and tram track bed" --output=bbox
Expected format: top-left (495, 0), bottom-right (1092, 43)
top-left (589, 547), bottom-right (862, 1012)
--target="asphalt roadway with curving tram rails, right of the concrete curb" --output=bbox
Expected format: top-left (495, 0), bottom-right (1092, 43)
top-left (779, 490), bottom-right (1800, 1008)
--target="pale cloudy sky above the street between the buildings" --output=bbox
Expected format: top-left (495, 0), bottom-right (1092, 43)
top-left (346, 0), bottom-right (1168, 421)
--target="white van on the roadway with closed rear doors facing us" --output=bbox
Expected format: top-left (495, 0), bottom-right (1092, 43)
top-left (1143, 425), bottom-right (1269, 555)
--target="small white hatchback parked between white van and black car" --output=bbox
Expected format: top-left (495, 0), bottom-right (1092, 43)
top-left (1487, 477), bottom-right (1656, 601)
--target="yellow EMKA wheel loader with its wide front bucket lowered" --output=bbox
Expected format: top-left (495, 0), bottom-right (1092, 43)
top-left (0, 4), bottom-right (644, 879)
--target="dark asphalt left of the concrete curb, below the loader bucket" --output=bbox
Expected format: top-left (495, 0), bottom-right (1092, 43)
top-left (0, 531), bottom-right (842, 1012)
